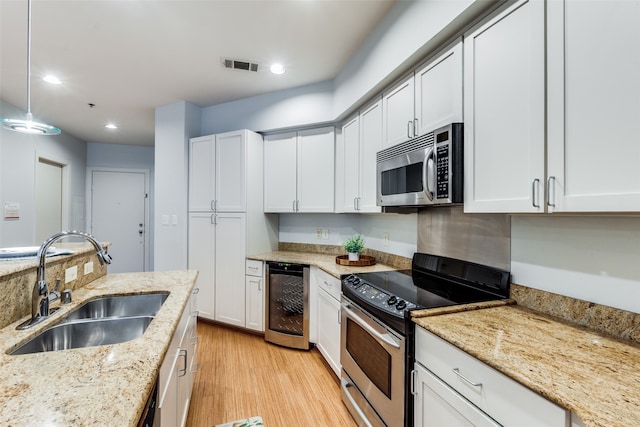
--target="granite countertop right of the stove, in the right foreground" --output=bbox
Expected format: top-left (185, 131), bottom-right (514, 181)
top-left (414, 305), bottom-right (640, 427)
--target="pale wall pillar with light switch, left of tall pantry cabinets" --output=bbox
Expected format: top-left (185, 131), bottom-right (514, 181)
top-left (154, 102), bottom-right (200, 271)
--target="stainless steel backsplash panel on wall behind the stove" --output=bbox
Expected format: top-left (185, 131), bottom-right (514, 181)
top-left (418, 206), bottom-right (511, 270)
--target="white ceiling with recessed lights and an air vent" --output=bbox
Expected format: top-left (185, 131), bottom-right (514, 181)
top-left (0, 0), bottom-right (395, 145)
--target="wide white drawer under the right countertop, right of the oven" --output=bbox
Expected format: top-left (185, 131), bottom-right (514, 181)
top-left (416, 327), bottom-right (567, 427)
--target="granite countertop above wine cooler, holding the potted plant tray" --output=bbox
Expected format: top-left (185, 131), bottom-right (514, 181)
top-left (247, 251), bottom-right (398, 279)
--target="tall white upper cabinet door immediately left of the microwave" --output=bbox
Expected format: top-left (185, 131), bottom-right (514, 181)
top-left (358, 100), bottom-right (382, 212)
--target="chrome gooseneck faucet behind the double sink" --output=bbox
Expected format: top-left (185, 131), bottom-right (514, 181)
top-left (18, 231), bottom-right (111, 329)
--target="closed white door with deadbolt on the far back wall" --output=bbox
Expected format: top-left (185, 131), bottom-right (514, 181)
top-left (91, 170), bottom-right (147, 273)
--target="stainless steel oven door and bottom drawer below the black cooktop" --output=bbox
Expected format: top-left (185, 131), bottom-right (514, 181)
top-left (340, 296), bottom-right (406, 426)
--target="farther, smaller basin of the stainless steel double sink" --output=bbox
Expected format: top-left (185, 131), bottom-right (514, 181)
top-left (63, 292), bottom-right (169, 322)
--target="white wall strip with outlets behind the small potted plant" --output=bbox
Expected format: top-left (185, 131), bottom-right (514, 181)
top-left (279, 213), bottom-right (418, 258)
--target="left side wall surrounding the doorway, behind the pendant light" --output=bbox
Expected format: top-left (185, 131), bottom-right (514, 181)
top-left (0, 100), bottom-right (87, 247)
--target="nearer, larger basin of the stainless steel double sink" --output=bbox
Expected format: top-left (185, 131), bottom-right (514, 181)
top-left (9, 316), bottom-right (153, 355)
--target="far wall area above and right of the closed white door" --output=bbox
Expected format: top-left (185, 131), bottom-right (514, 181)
top-left (87, 142), bottom-right (155, 271)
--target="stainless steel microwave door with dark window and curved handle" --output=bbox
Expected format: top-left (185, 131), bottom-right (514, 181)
top-left (377, 145), bottom-right (436, 206)
